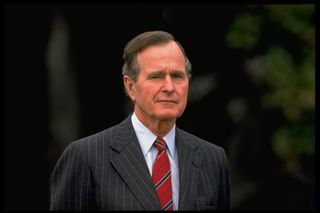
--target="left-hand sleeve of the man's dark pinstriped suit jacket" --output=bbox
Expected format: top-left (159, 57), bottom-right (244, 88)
top-left (50, 141), bottom-right (96, 210)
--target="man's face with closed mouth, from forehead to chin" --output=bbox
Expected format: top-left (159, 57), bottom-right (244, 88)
top-left (128, 41), bottom-right (189, 121)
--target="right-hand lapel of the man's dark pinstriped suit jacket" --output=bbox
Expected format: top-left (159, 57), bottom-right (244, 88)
top-left (176, 128), bottom-right (200, 210)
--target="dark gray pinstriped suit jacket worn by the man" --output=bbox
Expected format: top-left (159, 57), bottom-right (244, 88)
top-left (50, 116), bottom-right (230, 210)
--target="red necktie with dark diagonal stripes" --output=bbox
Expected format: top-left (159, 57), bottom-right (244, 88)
top-left (152, 137), bottom-right (173, 211)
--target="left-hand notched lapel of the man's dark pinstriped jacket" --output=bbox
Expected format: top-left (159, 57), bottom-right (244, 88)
top-left (110, 116), bottom-right (160, 210)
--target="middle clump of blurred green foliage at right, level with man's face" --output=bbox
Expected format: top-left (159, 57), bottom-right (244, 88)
top-left (262, 46), bottom-right (315, 121)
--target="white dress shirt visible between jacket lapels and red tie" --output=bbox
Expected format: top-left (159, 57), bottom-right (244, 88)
top-left (131, 113), bottom-right (179, 210)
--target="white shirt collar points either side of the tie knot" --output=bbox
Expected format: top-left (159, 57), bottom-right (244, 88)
top-left (131, 113), bottom-right (176, 157)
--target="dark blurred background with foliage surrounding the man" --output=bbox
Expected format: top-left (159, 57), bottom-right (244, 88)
top-left (5, 3), bottom-right (316, 210)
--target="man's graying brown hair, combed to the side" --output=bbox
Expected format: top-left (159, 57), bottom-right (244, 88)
top-left (122, 31), bottom-right (191, 82)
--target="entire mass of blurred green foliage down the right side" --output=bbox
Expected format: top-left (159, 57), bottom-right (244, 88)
top-left (226, 4), bottom-right (315, 174)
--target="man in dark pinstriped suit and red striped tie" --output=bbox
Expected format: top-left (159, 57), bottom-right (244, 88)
top-left (50, 31), bottom-right (230, 210)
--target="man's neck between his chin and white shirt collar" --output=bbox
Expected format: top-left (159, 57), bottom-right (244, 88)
top-left (135, 111), bottom-right (176, 137)
